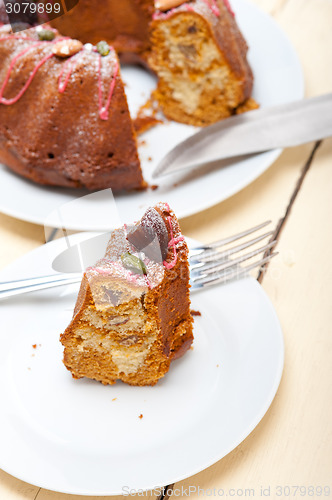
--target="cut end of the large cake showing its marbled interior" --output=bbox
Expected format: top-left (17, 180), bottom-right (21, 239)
top-left (149, 2), bottom-right (257, 126)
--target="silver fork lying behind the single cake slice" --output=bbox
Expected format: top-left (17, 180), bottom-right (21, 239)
top-left (0, 221), bottom-right (277, 299)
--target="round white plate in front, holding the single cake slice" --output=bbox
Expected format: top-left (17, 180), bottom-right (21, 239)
top-left (0, 234), bottom-right (284, 495)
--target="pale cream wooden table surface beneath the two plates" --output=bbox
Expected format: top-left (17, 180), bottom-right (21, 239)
top-left (0, 0), bottom-right (332, 500)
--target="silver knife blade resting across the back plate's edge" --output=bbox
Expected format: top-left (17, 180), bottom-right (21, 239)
top-left (152, 93), bottom-right (332, 178)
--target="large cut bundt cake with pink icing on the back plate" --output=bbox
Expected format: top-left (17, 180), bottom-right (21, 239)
top-left (0, 0), bottom-right (256, 190)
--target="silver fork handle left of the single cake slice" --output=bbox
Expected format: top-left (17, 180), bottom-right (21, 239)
top-left (0, 274), bottom-right (82, 300)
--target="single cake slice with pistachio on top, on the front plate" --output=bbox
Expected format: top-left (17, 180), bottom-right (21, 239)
top-left (61, 203), bottom-right (193, 385)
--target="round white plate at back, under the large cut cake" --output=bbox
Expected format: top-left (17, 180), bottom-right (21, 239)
top-left (0, 0), bottom-right (304, 231)
